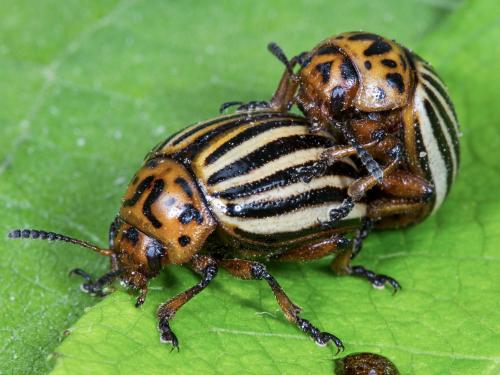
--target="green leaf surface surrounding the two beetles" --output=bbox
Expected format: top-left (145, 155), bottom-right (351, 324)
top-left (0, 0), bottom-right (500, 374)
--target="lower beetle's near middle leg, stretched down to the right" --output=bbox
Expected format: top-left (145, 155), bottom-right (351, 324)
top-left (220, 259), bottom-right (344, 353)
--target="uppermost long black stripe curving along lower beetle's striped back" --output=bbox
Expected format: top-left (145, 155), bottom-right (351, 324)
top-left (171, 112), bottom-right (292, 165)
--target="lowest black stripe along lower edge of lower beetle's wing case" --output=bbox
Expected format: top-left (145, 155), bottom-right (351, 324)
top-left (234, 216), bottom-right (360, 245)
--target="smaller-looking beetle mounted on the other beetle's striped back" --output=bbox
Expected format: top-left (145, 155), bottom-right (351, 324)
top-left (221, 32), bottom-right (460, 226)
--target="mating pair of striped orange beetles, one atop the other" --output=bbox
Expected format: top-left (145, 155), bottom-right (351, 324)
top-left (9, 34), bottom-right (458, 350)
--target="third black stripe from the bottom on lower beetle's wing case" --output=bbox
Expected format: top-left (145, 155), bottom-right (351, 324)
top-left (213, 161), bottom-right (359, 200)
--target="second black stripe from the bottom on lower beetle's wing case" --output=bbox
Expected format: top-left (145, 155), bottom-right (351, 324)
top-left (225, 186), bottom-right (347, 218)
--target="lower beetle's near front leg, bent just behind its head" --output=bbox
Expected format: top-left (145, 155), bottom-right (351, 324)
top-left (156, 255), bottom-right (218, 349)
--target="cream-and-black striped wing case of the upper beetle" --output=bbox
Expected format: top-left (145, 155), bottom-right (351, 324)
top-left (404, 55), bottom-right (460, 212)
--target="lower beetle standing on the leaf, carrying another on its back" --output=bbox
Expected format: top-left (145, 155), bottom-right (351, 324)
top-left (9, 111), bottom-right (400, 350)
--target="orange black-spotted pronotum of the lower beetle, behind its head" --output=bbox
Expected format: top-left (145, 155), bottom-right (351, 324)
top-left (120, 157), bottom-right (215, 265)
